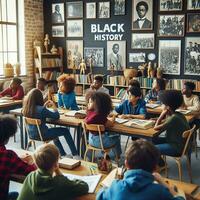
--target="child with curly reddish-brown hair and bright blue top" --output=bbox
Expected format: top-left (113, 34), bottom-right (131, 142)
top-left (57, 77), bottom-right (79, 110)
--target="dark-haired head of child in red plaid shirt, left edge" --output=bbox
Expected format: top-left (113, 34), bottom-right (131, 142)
top-left (0, 114), bottom-right (17, 145)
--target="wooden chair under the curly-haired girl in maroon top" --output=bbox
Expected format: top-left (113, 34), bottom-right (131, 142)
top-left (80, 122), bottom-right (118, 163)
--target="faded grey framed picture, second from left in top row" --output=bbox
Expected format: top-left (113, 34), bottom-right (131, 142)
top-left (66, 1), bottom-right (83, 18)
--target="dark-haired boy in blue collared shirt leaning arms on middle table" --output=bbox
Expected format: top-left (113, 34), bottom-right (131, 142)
top-left (115, 86), bottom-right (147, 119)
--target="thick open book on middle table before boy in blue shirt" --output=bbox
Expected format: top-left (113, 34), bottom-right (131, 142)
top-left (124, 119), bottom-right (155, 129)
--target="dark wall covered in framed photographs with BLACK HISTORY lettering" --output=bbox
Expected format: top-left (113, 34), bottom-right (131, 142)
top-left (44, 0), bottom-right (200, 80)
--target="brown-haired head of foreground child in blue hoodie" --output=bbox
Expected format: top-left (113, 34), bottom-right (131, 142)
top-left (125, 139), bottom-right (160, 173)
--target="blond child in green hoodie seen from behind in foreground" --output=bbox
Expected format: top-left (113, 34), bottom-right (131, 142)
top-left (18, 144), bottom-right (88, 200)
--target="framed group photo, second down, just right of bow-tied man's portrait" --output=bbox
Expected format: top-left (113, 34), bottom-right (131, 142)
top-left (158, 15), bottom-right (185, 37)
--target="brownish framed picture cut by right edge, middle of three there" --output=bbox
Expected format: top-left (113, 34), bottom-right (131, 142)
top-left (187, 13), bottom-right (200, 33)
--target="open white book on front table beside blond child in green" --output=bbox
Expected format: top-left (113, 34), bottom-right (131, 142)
top-left (63, 174), bottom-right (102, 193)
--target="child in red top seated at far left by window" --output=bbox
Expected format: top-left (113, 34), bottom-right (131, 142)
top-left (0, 77), bottom-right (24, 100)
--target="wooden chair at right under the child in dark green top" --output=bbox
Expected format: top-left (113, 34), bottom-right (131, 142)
top-left (163, 125), bottom-right (196, 183)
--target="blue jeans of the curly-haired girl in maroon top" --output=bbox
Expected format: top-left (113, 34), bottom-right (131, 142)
top-left (89, 132), bottom-right (122, 157)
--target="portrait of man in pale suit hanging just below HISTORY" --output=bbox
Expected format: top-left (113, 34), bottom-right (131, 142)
top-left (107, 41), bottom-right (126, 71)
